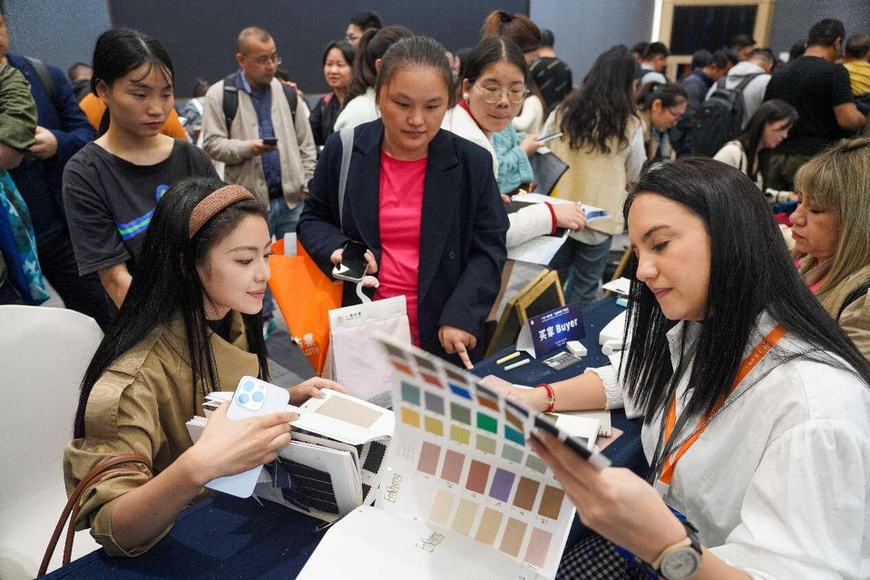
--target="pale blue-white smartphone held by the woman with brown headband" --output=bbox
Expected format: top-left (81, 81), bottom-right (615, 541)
top-left (205, 376), bottom-right (290, 498)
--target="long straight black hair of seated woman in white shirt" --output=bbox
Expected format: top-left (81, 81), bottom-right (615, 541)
top-left (622, 158), bottom-right (870, 423)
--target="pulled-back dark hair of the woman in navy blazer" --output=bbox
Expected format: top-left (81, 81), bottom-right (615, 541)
top-left (375, 36), bottom-right (455, 108)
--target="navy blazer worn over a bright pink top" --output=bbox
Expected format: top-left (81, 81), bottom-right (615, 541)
top-left (296, 120), bottom-right (508, 363)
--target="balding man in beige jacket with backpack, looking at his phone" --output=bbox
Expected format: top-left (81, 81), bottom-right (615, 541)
top-left (202, 26), bottom-right (317, 336)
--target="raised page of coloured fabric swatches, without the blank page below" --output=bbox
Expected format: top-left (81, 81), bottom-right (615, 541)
top-left (377, 342), bottom-right (574, 578)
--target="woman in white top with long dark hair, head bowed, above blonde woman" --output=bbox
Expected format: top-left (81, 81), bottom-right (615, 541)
top-left (713, 99), bottom-right (798, 203)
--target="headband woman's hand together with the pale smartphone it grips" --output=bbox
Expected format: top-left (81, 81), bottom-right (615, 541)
top-left (205, 376), bottom-right (292, 498)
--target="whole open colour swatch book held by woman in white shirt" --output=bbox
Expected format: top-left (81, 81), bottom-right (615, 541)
top-left (299, 337), bottom-right (609, 580)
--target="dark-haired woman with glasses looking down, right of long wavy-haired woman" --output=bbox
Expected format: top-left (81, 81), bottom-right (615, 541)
top-left (637, 81), bottom-right (689, 161)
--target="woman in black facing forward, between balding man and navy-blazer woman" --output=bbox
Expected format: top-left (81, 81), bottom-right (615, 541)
top-left (308, 40), bottom-right (353, 147)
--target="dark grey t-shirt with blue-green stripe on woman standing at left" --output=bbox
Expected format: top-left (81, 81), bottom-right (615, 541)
top-left (63, 140), bottom-right (217, 276)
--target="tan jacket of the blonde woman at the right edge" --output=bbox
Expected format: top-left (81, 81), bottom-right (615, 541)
top-left (800, 256), bottom-right (870, 361)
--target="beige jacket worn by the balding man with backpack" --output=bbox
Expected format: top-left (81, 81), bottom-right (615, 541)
top-left (202, 79), bottom-right (317, 208)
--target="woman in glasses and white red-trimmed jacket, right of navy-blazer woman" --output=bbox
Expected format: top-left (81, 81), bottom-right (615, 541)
top-left (441, 37), bottom-right (586, 248)
